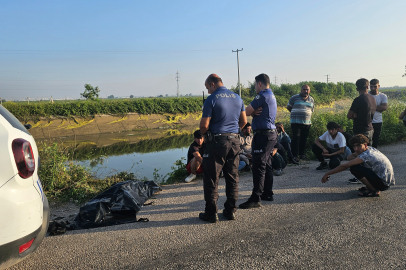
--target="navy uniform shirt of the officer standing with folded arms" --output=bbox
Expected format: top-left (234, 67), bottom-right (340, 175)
top-left (251, 88), bottom-right (277, 131)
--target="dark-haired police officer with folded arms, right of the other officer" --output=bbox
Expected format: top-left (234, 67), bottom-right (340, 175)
top-left (240, 74), bottom-right (277, 209)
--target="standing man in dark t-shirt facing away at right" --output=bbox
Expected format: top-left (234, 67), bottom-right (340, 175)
top-left (347, 79), bottom-right (376, 146)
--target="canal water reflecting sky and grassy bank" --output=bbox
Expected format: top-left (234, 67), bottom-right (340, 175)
top-left (54, 130), bottom-right (194, 179)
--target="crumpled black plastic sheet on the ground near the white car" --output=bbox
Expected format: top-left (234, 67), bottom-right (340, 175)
top-left (72, 180), bottom-right (161, 229)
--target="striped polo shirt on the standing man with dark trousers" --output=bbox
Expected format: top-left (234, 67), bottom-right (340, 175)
top-left (288, 94), bottom-right (314, 125)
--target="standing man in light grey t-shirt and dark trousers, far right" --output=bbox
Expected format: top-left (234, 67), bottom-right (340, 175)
top-left (369, 79), bottom-right (388, 148)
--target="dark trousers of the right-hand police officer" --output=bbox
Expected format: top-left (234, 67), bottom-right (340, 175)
top-left (249, 131), bottom-right (277, 202)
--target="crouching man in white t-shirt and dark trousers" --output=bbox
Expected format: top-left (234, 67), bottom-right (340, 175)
top-left (312, 122), bottom-right (347, 170)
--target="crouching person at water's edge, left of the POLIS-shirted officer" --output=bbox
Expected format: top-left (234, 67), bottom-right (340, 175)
top-left (185, 130), bottom-right (206, 183)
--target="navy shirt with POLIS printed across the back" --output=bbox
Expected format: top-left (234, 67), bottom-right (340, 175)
top-left (202, 86), bottom-right (245, 134)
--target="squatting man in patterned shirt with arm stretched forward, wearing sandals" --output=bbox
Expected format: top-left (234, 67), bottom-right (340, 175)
top-left (321, 134), bottom-right (395, 197)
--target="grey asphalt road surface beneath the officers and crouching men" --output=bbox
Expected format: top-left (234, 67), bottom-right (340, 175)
top-left (10, 142), bottom-right (406, 270)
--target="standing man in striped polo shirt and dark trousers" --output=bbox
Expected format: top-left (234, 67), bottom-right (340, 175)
top-left (287, 84), bottom-right (314, 163)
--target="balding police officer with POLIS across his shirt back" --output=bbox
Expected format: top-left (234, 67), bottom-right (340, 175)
top-left (199, 74), bottom-right (247, 223)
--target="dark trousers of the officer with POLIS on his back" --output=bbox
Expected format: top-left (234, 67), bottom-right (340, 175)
top-left (203, 136), bottom-right (241, 215)
